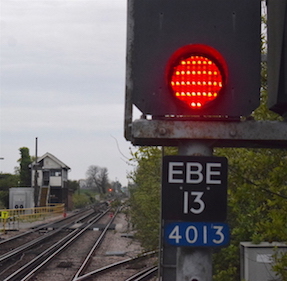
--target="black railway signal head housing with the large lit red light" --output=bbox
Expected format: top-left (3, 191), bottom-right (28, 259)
top-left (126, 0), bottom-right (261, 118)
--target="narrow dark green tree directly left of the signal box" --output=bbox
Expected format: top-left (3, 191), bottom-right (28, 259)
top-left (18, 147), bottom-right (32, 187)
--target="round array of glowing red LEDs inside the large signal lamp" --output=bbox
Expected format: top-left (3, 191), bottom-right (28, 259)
top-left (170, 56), bottom-right (223, 108)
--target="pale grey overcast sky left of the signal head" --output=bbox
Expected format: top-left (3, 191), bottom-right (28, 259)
top-left (0, 0), bottom-right (137, 185)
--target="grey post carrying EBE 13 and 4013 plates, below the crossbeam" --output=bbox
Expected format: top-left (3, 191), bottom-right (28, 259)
top-left (162, 144), bottom-right (229, 281)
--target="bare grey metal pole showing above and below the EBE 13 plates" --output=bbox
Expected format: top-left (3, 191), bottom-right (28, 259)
top-left (176, 141), bottom-right (213, 281)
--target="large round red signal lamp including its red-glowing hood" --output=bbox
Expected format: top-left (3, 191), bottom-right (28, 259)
top-left (168, 44), bottom-right (227, 109)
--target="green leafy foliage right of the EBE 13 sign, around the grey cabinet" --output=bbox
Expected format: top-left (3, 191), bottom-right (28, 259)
top-left (214, 148), bottom-right (287, 281)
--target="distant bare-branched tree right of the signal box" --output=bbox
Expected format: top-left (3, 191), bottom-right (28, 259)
top-left (86, 165), bottom-right (109, 194)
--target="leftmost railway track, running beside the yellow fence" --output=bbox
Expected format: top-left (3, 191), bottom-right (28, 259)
top-left (0, 206), bottom-right (108, 281)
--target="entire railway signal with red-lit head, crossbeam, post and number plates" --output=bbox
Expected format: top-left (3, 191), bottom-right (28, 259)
top-left (125, 0), bottom-right (287, 281)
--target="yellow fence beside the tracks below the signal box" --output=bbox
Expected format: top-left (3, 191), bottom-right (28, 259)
top-left (0, 204), bottom-right (65, 223)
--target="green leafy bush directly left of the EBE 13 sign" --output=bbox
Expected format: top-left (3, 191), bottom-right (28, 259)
top-left (130, 147), bottom-right (175, 250)
